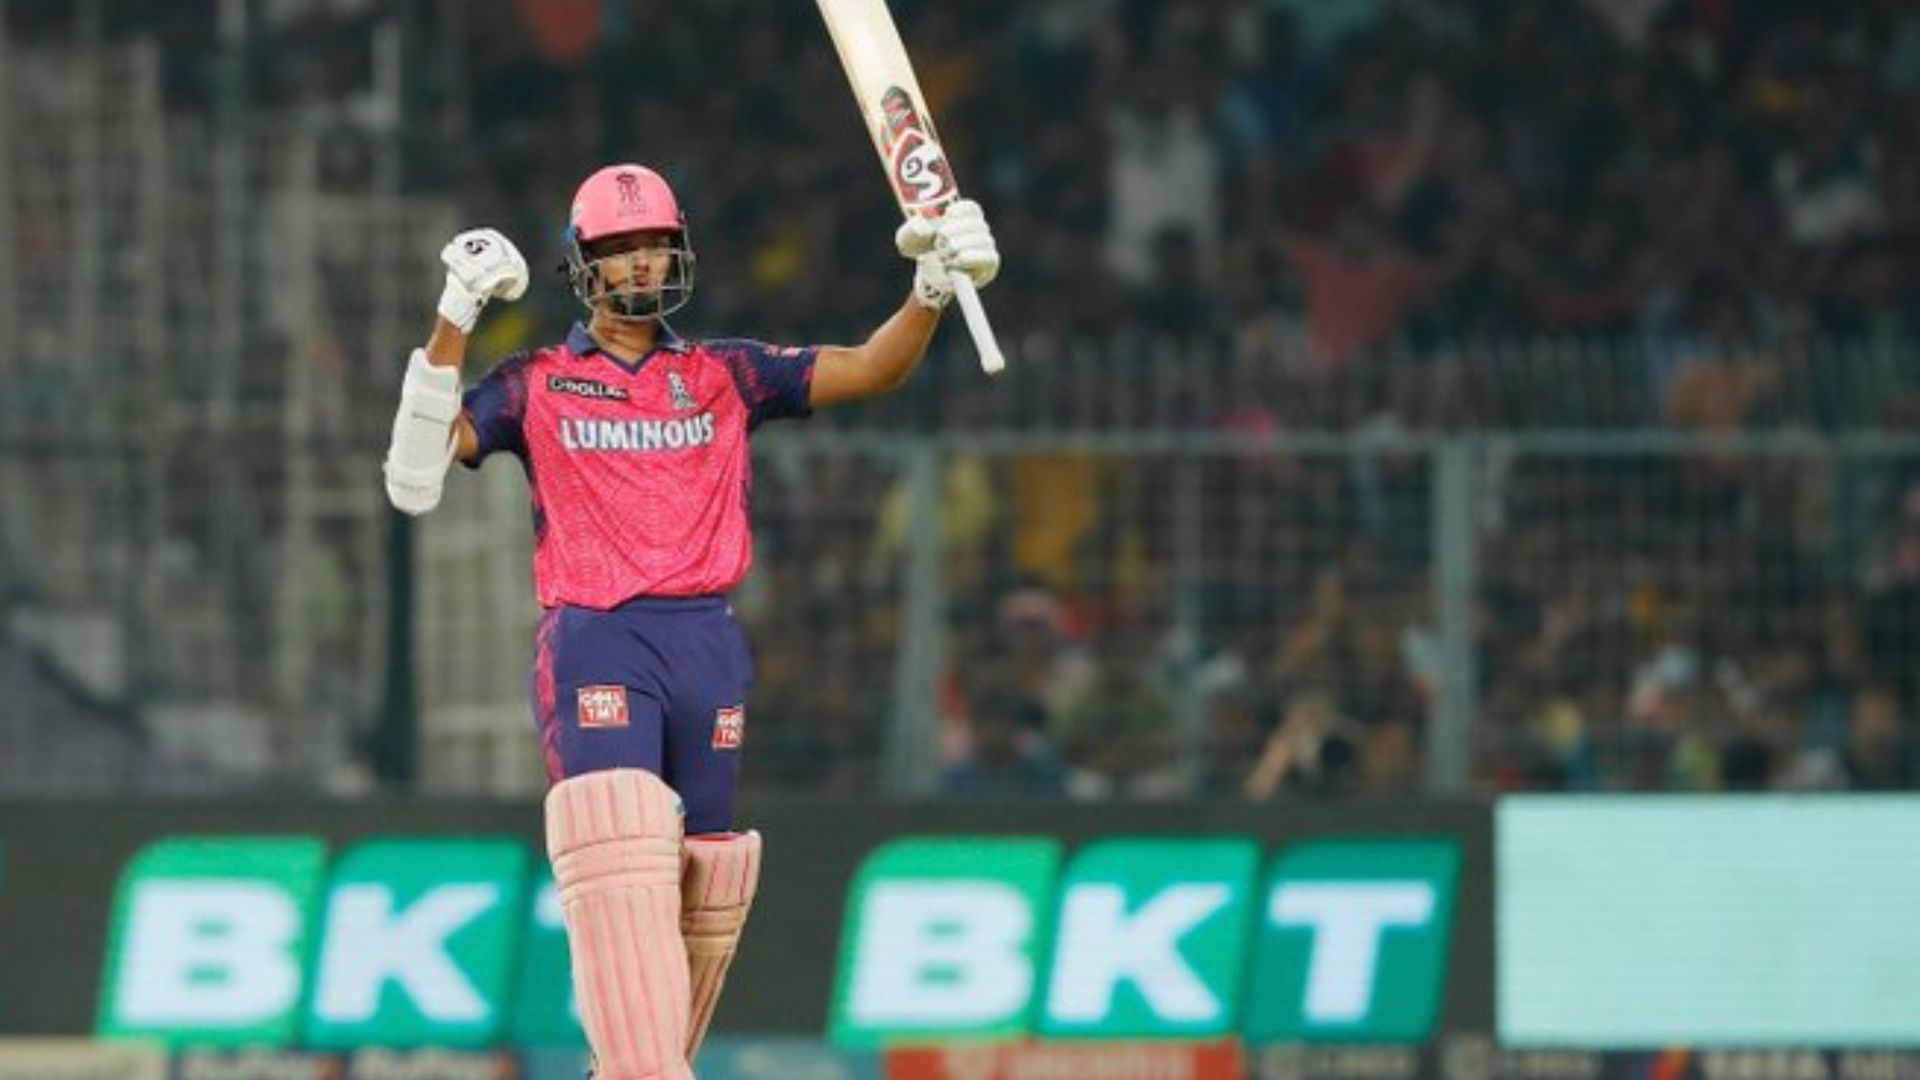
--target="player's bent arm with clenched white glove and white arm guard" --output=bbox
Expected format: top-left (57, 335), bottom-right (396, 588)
top-left (384, 229), bottom-right (526, 515)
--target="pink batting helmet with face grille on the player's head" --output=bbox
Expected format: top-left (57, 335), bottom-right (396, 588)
top-left (566, 163), bottom-right (693, 319)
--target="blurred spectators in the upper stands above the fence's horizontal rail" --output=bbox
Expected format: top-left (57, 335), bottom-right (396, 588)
top-left (449, 0), bottom-right (1920, 429)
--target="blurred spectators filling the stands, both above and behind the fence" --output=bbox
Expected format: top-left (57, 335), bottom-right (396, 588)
top-left (3, 0), bottom-right (1920, 799)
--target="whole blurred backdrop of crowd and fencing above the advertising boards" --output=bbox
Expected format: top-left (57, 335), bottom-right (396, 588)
top-left (0, 0), bottom-right (1920, 1076)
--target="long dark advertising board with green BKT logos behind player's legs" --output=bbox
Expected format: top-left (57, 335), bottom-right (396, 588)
top-left (0, 801), bottom-right (1492, 1059)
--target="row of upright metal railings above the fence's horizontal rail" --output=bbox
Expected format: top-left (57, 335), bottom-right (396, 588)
top-left (824, 330), bottom-right (1920, 434)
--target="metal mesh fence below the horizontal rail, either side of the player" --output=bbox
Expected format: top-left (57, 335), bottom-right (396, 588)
top-left (419, 432), bottom-right (1920, 799)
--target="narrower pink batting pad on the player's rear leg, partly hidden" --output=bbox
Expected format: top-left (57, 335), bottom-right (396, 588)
top-left (680, 832), bottom-right (760, 1061)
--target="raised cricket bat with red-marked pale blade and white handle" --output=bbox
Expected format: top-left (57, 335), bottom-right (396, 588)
top-left (818, 0), bottom-right (1006, 375)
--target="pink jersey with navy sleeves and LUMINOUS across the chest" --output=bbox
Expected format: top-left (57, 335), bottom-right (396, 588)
top-left (465, 325), bottom-right (816, 611)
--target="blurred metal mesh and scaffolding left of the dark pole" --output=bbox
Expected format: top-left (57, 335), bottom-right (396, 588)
top-left (0, 38), bottom-right (451, 790)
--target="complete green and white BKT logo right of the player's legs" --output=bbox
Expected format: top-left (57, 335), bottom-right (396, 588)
top-left (833, 838), bottom-right (1459, 1047)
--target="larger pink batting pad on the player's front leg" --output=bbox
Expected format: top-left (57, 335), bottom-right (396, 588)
top-left (547, 769), bottom-right (693, 1080)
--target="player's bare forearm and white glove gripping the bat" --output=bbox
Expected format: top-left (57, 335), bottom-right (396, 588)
top-left (808, 200), bottom-right (1000, 409)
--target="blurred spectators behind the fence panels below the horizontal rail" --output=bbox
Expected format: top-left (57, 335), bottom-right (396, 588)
top-left (743, 441), bottom-right (1920, 799)
